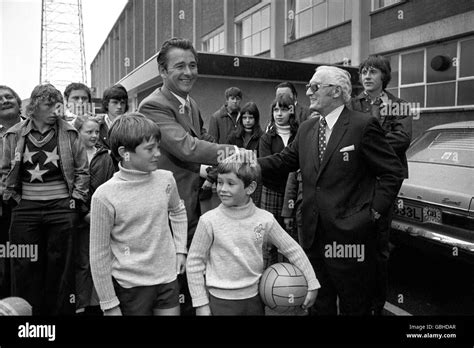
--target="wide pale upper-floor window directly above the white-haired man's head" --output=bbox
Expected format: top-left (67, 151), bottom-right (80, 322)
top-left (288, 0), bottom-right (352, 40)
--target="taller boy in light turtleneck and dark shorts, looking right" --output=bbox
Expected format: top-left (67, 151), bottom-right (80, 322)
top-left (90, 113), bottom-right (187, 315)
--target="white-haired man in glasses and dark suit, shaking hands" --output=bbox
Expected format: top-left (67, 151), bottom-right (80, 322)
top-left (258, 66), bottom-right (403, 315)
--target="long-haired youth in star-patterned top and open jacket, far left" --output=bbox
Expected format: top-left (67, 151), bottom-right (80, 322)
top-left (1, 84), bottom-right (89, 315)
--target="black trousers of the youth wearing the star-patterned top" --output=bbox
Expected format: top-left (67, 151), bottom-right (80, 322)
top-left (10, 198), bottom-right (78, 315)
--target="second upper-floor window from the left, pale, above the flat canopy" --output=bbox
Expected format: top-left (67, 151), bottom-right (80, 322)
top-left (235, 6), bottom-right (270, 56)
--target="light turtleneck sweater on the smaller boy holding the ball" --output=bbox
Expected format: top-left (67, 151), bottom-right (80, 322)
top-left (186, 200), bottom-right (320, 307)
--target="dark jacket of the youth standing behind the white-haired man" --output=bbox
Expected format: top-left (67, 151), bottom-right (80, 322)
top-left (351, 91), bottom-right (412, 178)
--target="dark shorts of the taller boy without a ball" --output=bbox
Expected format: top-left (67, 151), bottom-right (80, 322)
top-left (112, 277), bottom-right (179, 315)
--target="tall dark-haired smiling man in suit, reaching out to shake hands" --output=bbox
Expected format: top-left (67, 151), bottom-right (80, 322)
top-left (138, 38), bottom-right (237, 313)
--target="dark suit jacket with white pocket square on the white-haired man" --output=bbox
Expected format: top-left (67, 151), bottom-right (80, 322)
top-left (258, 107), bottom-right (403, 249)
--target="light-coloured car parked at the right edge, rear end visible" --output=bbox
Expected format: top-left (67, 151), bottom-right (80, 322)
top-left (391, 121), bottom-right (474, 261)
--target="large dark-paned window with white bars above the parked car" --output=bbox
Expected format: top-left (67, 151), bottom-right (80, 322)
top-left (387, 38), bottom-right (474, 108)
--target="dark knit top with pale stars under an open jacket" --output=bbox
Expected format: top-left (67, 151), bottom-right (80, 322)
top-left (20, 129), bottom-right (69, 201)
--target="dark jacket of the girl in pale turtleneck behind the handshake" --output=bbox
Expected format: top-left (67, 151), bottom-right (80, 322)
top-left (259, 127), bottom-right (296, 193)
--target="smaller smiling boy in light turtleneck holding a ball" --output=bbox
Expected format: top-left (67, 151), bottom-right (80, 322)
top-left (186, 153), bottom-right (320, 315)
